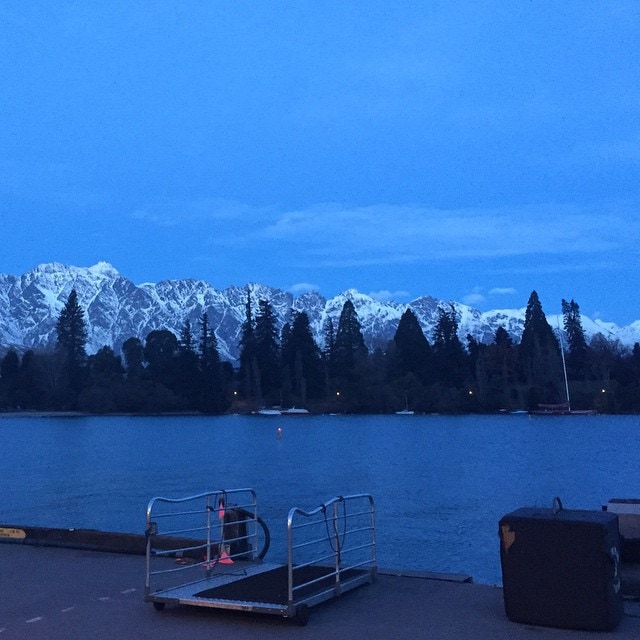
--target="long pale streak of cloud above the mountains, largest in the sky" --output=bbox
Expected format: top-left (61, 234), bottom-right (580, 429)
top-left (252, 205), bottom-right (640, 266)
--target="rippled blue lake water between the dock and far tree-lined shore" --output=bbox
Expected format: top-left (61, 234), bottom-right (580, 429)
top-left (0, 415), bottom-right (640, 584)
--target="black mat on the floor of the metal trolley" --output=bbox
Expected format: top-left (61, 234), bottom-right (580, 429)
top-left (195, 565), bottom-right (365, 604)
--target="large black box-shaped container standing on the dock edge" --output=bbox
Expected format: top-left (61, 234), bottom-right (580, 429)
top-left (499, 508), bottom-right (623, 631)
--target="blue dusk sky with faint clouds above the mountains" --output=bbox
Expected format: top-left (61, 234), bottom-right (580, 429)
top-left (0, 0), bottom-right (640, 325)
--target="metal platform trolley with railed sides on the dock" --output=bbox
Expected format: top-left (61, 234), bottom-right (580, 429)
top-left (145, 489), bottom-right (377, 625)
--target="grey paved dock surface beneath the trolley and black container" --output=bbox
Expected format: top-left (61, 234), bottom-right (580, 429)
top-left (0, 544), bottom-right (640, 640)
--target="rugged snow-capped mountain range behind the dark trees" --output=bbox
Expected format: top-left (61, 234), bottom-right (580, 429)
top-left (0, 262), bottom-right (640, 361)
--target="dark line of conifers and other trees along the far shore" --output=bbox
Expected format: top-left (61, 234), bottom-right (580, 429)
top-left (0, 290), bottom-right (640, 414)
